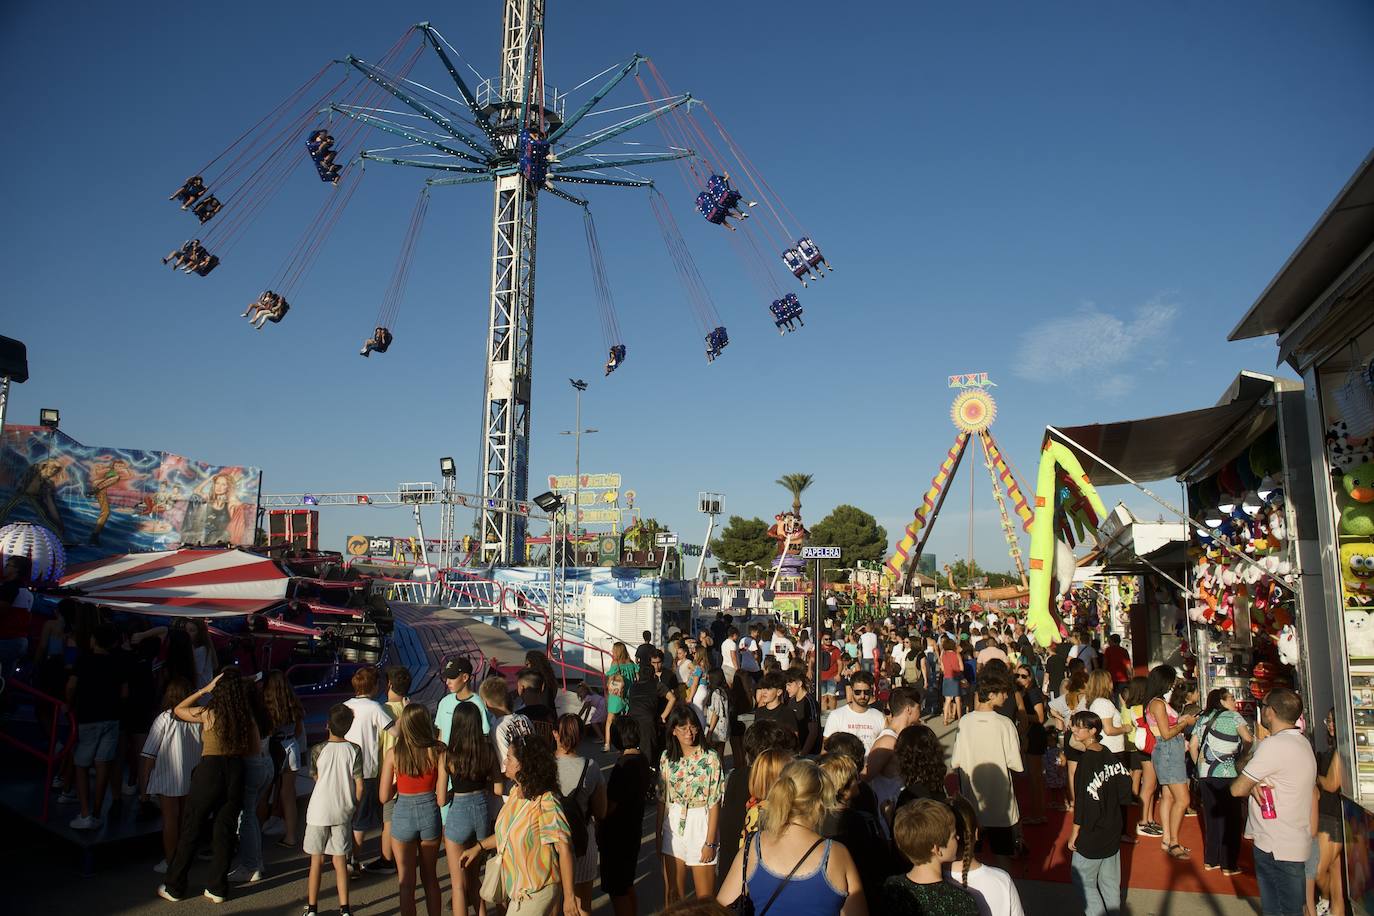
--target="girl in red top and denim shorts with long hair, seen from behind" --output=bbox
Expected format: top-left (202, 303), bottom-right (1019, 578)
top-left (381, 703), bottom-right (445, 916)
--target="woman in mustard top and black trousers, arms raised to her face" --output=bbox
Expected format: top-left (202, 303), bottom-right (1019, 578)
top-left (158, 667), bottom-right (262, 904)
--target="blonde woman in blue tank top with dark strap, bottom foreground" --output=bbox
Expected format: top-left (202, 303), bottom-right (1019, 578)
top-left (716, 758), bottom-right (868, 916)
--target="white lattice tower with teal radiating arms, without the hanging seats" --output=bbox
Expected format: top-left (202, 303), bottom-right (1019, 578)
top-left (330, 0), bottom-right (697, 564)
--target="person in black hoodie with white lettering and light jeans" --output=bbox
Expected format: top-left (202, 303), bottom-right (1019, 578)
top-left (1069, 710), bottom-right (1131, 916)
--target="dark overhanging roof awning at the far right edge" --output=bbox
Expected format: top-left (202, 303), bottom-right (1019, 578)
top-left (1227, 149), bottom-right (1374, 341)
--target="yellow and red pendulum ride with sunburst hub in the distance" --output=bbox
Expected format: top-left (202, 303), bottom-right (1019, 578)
top-left (883, 372), bottom-right (1033, 597)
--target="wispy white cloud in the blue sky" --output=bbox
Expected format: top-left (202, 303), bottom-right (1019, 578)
top-left (1014, 299), bottom-right (1178, 398)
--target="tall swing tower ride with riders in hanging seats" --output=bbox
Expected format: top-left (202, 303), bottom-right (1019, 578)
top-left (164, 0), bottom-right (831, 564)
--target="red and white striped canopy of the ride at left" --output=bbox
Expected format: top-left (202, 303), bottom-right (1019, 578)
top-left (60, 548), bottom-right (291, 617)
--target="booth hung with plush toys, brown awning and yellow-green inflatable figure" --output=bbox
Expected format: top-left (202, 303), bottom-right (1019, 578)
top-left (1031, 372), bottom-right (1330, 726)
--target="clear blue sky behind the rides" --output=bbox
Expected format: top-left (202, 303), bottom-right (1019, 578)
top-left (0, 0), bottom-right (1374, 569)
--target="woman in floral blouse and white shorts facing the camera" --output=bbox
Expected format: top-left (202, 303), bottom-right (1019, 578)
top-left (658, 706), bottom-right (725, 906)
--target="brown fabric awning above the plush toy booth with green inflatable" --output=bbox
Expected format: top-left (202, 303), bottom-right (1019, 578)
top-left (1052, 372), bottom-right (1296, 486)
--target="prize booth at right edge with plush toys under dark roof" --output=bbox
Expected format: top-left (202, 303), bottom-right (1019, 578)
top-left (1230, 149), bottom-right (1374, 807)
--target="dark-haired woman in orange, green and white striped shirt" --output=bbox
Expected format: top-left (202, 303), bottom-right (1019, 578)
top-left (459, 732), bottom-right (587, 916)
